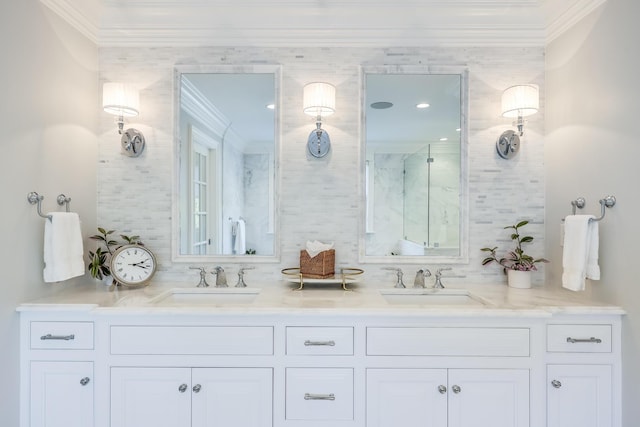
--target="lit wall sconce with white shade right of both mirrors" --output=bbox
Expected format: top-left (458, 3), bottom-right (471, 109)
top-left (496, 85), bottom-right (540, 159)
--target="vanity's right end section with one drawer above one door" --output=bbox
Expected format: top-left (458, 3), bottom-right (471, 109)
top-left (547, 318), bottom-right (620, 427)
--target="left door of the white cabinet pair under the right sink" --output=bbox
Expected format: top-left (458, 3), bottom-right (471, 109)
top-left (367, 369), bottom-right (447, 427)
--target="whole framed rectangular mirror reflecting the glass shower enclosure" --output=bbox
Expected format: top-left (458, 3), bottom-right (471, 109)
top-left (360, 66), bottom-right (468, 263)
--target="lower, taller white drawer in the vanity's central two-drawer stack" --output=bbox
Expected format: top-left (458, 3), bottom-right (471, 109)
top-left (285, 368), bottom-right (353, 421)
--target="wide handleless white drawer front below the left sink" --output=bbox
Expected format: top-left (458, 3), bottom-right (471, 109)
top-left (111, 326), bottom-right (273, 355)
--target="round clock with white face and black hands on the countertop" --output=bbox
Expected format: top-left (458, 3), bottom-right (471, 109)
top-left (111, 245), bottom-right (157, 285)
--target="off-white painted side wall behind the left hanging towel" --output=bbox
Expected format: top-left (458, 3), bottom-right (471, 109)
top-left (0, 1), bottom-right (99, 427)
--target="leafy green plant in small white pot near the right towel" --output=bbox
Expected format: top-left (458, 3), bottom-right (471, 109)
top-left (480, 221), bottom-right (549, 288)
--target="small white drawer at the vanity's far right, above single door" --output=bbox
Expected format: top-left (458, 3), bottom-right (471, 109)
top-left (547, 325), bottom-right (611, 353)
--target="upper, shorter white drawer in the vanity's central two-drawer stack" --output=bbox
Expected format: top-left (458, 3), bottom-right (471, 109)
top-left (287, 326), bottom-right (353, 355)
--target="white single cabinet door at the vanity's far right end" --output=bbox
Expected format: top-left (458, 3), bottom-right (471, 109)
top-left (547, 365), bottom-right (612, 427)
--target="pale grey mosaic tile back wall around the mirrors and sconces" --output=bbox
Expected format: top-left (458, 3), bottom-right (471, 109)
top-left (97, 47), bottom-right (544, 284)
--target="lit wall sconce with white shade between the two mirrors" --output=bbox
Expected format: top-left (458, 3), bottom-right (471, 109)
top-left (302, 82), bottom-right (336, 158)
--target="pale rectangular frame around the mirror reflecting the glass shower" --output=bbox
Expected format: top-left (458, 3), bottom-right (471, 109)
top-left (358, 65), bottom-right (469, 264)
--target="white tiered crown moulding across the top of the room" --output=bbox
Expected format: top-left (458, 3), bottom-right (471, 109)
top-left (40, 0), bottom-right (606, 47)
